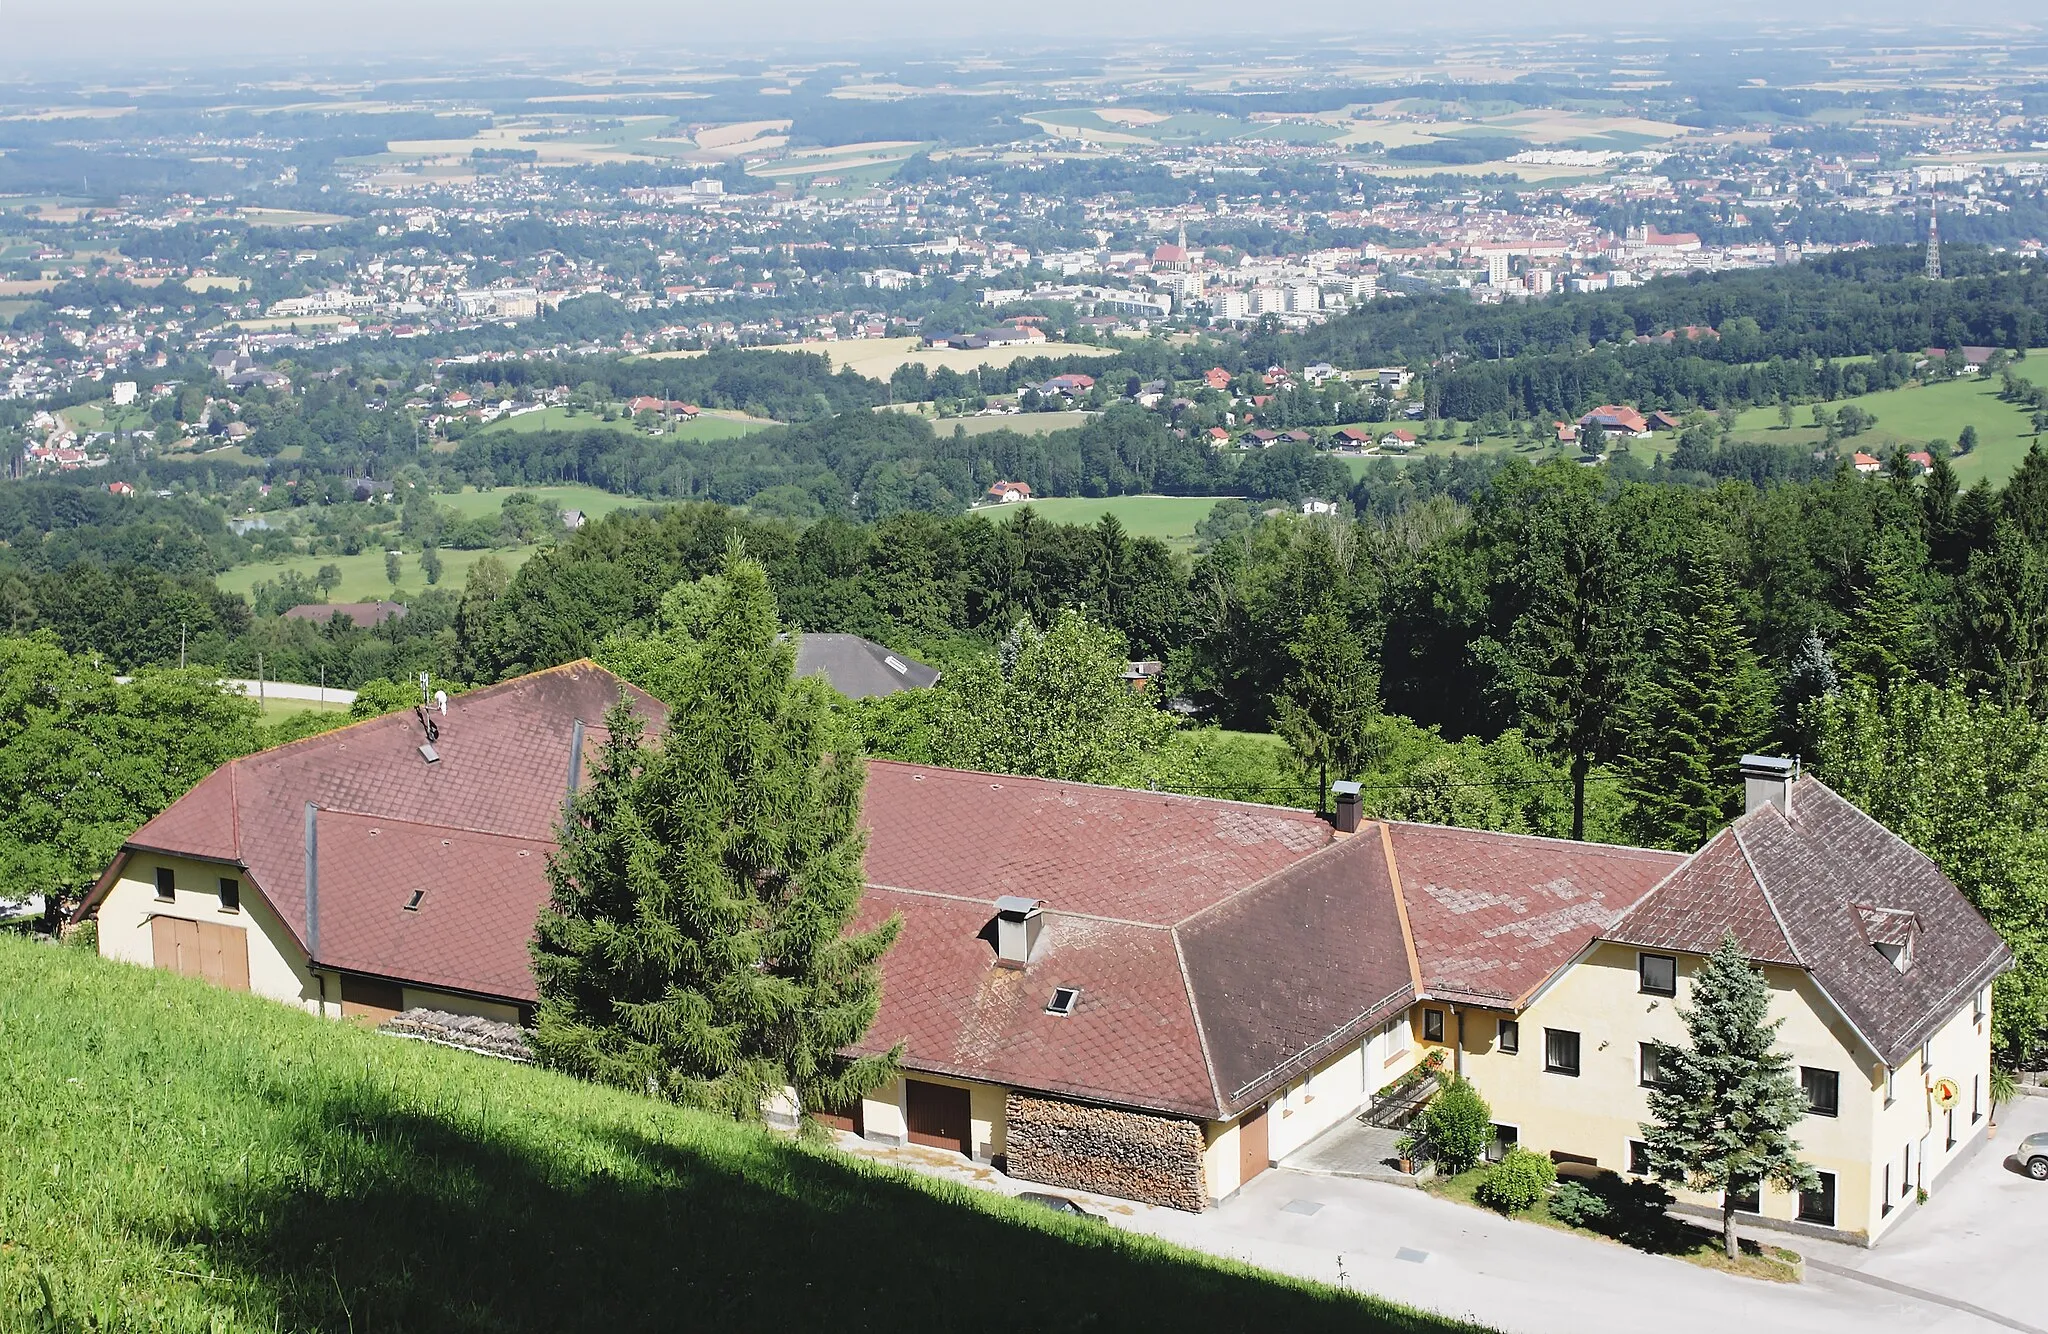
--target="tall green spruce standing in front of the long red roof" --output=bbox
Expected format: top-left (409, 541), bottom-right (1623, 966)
top-left (532, 547), bottom-right (901, 1119)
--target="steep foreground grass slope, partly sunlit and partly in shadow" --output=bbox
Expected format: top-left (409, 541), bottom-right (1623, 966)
top-left (0, 936), bottom-right (1468, 1334)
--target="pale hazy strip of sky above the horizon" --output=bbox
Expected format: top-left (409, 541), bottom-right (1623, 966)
top-left (0, 0), bottom-right (2048, 76)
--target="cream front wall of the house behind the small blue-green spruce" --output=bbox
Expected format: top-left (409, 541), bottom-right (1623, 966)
top-left (1464, 945), bottom-right (1878, 1229)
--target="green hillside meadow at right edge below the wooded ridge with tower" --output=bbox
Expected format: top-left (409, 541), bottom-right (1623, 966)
top-left (1735, 370), bottom-right (2048, 486)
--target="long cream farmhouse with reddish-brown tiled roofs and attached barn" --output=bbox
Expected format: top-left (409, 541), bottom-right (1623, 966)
top-left (82, 664), bottom-right (2009, 1240)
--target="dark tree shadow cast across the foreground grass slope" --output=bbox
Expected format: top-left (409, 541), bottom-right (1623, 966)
top-left (151, 1090), bottom-right (1466, 1334)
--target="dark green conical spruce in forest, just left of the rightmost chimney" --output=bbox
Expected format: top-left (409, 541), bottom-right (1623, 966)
top-left (1622, 551), bottom-right (1772, 850)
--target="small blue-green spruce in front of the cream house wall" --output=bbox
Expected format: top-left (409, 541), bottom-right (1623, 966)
top-left (1642, 932), bottom-right (1821, 1260)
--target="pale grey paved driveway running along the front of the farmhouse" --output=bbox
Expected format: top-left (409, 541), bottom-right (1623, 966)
top-left (842, 1098), bottom-right (2048, 1334)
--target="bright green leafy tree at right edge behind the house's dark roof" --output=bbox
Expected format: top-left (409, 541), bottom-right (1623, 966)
top-left (1815, 682), bottom-right (2048, 1068)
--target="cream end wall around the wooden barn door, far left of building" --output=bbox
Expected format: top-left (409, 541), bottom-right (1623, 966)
top-left (98, 852), bottom-right (334, 1014)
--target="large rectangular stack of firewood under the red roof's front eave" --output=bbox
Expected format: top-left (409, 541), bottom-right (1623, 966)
top-left (1004, 1092), bottom-right (1208, 1213)
